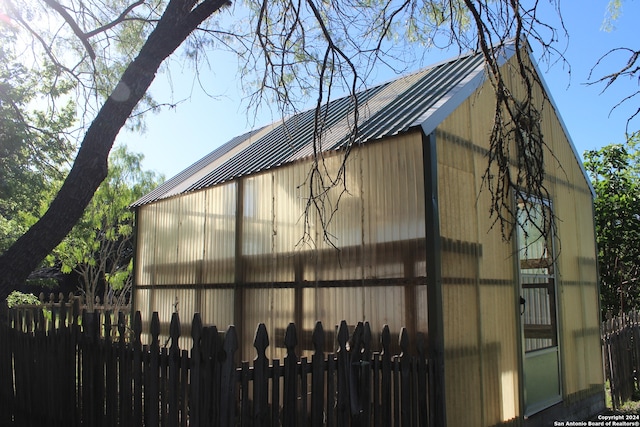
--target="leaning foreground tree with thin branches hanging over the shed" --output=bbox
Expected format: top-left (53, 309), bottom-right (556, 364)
top-left (0, 0), bottom-right (636, 304)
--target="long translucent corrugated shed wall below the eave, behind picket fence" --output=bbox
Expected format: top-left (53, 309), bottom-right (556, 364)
top-left (135, 130), bottom-right (427, 359)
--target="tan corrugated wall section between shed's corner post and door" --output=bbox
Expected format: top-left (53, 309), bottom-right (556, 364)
top-left (436, 84), bottom-right (522, 426)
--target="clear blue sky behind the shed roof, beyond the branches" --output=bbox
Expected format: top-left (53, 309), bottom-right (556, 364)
top-left (117, 0), bottom-right (640, 179)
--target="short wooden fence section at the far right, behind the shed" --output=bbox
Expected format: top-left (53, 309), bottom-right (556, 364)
top-left (602, 310), bottom-right (640, 409)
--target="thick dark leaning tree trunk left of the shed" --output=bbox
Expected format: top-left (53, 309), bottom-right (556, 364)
top-left (0, 0), bottom-right (228, 304)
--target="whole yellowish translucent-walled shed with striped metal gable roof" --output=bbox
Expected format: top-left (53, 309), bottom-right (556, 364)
top-left (133, 41), bottom-right (604, 426)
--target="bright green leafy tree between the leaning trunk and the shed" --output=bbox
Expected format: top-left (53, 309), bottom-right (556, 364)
top-left (48, 147), bottom-right (162, 310)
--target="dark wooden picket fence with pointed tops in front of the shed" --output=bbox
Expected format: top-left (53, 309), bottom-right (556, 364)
top-left (0, 307), bottom-right (434, 427)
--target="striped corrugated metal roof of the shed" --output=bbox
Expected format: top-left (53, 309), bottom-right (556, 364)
top-left (131, 44), bottom-right (514, 208)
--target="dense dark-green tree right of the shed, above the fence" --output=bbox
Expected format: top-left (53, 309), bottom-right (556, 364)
top-left (584, 133), bottom-right (640, 317)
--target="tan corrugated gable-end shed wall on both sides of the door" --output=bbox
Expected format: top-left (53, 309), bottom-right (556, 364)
top-left (437, 51), bottom-right (603, 426)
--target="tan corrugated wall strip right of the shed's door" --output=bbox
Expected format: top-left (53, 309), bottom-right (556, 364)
top-left (502, 57), bottom-right (604, 404)
